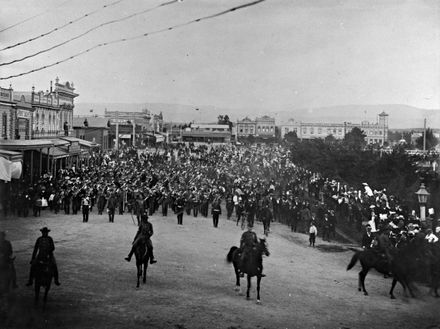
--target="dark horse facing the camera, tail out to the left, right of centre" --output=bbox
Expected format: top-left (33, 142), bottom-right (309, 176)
top-left (226, 239), bottom-right (269, 303)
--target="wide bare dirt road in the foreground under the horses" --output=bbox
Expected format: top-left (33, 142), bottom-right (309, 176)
top-left (0, 211), bottom-right (440, 329)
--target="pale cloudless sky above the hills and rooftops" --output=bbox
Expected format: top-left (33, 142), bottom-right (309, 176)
top-left (0, 0), bottom-right (440, 111)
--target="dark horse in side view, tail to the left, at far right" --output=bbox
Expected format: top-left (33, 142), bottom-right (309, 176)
top-left (347, 236), bottom-right (423, 299)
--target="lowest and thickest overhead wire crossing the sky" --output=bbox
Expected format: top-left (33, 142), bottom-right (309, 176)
top-left (0, 0), bottom-right (266, 81)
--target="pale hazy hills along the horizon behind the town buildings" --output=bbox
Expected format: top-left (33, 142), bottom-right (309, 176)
top-left (74, 103), bottom-right (440, 129)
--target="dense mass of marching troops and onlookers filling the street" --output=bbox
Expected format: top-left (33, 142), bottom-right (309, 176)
top-left (3, 144), bottom-right (436, 240)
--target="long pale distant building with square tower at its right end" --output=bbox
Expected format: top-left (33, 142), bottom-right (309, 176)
top-left (280, 112), bottom-right (388, 145)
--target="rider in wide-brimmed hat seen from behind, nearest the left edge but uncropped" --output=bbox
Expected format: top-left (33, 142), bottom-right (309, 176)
top-left (26, 227), bottom-right (60, 286)
